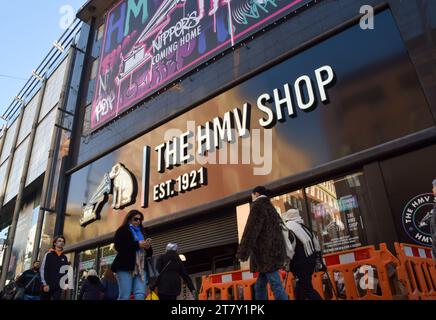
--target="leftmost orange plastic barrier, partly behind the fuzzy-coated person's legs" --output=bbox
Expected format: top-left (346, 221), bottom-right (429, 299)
top-left (198, 270), bottom-right (293, 300)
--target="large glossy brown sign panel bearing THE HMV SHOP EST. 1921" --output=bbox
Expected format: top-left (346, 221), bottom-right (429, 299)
top-left (65, 10), bottom-right (432, 245)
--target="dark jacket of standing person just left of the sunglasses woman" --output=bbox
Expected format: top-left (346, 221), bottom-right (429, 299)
top-left (40, 249), bottom-right (68, 292)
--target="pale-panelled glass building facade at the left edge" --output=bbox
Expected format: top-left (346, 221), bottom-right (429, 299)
top-left (0, 20), bottom-right (86, 288)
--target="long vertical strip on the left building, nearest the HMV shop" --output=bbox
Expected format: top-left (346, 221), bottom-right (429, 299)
top-left (31, 45), bottom-right (76, 264)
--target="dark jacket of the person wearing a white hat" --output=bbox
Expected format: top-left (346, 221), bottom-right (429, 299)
top-left (156, 251), bottom-right (195, 296)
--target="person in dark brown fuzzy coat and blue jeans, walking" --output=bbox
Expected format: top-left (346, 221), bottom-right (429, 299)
top-left (236, 186), bottom-right (288, 300)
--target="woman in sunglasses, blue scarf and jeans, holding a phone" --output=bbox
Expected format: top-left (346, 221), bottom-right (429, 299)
top-left (111, 210), bottom-right (153, 300)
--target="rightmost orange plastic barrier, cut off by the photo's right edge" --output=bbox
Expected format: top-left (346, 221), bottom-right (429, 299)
top-left (395, 242), bottom-right (436, 300)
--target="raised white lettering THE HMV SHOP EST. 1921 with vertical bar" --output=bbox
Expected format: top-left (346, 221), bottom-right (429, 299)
top-left (142, 65), bottom-right (336, 208)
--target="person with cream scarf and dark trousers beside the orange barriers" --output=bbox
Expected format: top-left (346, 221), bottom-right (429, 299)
top-left (282, 209), bottom-right (322, 300)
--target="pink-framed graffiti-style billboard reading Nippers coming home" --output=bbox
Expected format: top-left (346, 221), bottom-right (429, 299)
top-left (91, 0), bottom-right (307, 129)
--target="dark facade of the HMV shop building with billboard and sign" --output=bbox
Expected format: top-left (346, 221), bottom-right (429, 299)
top-left (1, 0), bottom-right (436, 300)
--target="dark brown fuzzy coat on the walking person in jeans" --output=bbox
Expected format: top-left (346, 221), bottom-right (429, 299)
top-left (237, 197), bottom-right (286, 273)
